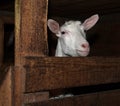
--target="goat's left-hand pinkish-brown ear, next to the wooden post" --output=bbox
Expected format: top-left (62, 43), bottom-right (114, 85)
top-left (48, 19), bottom-right (60, 34)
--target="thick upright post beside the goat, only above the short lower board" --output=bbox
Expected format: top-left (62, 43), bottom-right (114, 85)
top-left (15, 0), bottom-right (48, 65)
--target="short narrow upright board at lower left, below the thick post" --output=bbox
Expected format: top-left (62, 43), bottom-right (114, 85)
top-left (13, 67), bottom-right (25, 106)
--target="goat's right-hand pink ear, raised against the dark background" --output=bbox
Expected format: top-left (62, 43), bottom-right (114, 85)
top-left (82, 14), bottom-right (99, 30)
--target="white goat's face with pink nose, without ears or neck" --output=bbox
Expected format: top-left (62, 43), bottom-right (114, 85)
top-left (57, 21), bottom-right (90, 56)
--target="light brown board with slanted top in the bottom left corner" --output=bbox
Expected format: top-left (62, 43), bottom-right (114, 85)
top-left (0, 67), bottom-right (13, 106)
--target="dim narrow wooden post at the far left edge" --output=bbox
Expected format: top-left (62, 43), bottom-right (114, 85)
top-left (0, 19), bottom-right (4, 65)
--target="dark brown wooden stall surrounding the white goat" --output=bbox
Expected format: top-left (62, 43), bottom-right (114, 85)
top-left (0, 0), bottom-right (120, 106)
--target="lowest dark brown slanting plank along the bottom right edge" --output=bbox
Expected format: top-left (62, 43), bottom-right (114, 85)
top-left (25, 90), bottom-right (120, 106)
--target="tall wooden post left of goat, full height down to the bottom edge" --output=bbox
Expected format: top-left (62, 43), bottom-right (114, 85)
top-left (14, 0), bottom-right (48, 106)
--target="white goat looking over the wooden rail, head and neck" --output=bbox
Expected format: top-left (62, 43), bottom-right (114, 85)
top-left (48, 14), bottom-right (99, 57)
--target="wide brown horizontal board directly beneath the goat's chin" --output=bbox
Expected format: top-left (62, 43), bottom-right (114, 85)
top-left (24, 57), bottom-right (120, 92)
